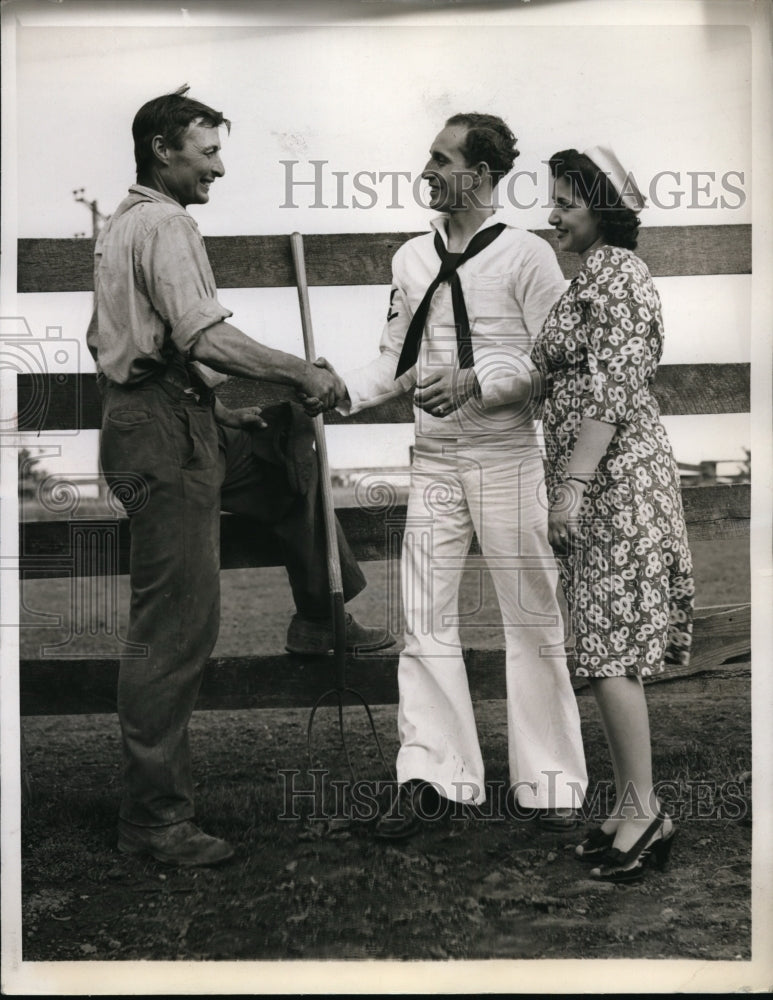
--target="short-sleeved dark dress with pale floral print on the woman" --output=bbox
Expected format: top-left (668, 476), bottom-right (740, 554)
top-left (532, 246), bottom-right (694, 677)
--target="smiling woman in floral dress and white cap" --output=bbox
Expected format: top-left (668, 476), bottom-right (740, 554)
top-left (532, 147), bottom-right (694, 882)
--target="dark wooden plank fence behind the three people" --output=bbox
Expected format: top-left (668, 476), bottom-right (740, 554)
top-left (17, 225), bottom-right (751, 714)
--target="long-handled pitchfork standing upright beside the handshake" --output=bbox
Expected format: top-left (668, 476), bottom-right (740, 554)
top-left (290, 233), bottom-right (392, 780)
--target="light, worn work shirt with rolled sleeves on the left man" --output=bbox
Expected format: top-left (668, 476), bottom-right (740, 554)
top-left (86, 184), bottom-right (232, 385)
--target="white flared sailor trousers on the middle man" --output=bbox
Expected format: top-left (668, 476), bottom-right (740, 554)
top-left (397, 436), bottom-right (587, 809)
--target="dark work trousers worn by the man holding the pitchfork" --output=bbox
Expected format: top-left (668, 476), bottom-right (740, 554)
top-left (100, 380), bottom-right (365, 826)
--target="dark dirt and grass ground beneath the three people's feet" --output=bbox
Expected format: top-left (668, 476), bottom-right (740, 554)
top-left (22, 668), bottom-right (751, 961)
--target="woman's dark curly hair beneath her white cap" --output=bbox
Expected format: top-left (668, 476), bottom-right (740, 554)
top-left (548, 149), bottom-right (641, 250)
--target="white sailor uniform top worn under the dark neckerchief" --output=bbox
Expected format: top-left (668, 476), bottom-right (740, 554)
top-left (339, 213), bottom-right (566, 440)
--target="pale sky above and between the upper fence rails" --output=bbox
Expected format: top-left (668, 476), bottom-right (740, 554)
top-left (6, 3), bottom-right (751, 471)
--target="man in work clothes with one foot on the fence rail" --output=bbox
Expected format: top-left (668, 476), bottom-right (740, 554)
top-left (88, 86), bottom-right (394, 865)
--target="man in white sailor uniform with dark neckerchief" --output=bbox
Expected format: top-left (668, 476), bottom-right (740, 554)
top-left (306, 114), bottom-right (587, 838)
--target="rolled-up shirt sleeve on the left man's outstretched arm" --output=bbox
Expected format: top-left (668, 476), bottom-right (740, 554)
top-left (141, 215), bottom-right (233, 357)
